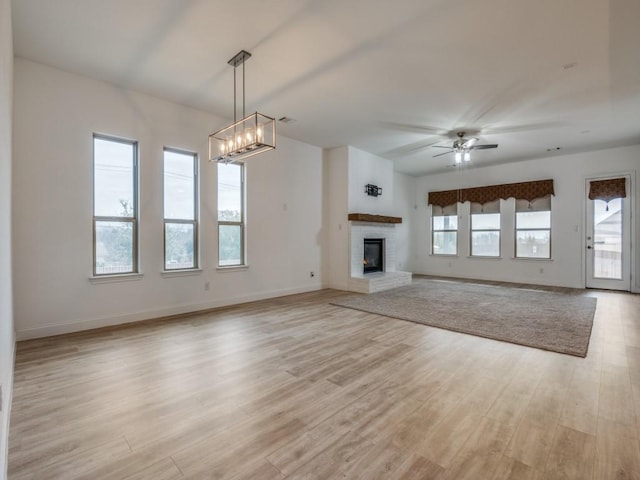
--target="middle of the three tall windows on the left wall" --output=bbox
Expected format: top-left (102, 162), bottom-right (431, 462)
top-left (164, 148), bottom-right (198, 270)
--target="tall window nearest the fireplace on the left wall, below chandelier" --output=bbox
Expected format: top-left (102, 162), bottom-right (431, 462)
top-left (218, 163), bottom-right (245, 267)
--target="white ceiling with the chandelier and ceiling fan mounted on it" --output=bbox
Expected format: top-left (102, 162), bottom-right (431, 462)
top-left (12, 0), bottom-right (640, 175)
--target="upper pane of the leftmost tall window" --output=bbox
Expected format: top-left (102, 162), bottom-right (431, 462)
top-left (93, 138), bottom-right (135, 217)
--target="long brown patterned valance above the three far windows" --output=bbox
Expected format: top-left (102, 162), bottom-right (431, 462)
top-left (428, 180), bottom-right (554, 207)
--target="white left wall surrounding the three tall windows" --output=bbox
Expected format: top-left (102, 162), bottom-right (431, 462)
top-left (12, 58), bottom-right (323, 339)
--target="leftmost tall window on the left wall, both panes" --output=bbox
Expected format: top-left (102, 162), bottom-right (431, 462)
top-left (93, 135), bottom-right (138, 276)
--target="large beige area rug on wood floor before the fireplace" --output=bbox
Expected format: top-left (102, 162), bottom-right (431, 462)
top-left (333, 279), bottom-right (597, 357)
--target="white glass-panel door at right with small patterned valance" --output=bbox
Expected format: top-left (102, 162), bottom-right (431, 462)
top-left (585, 175), bottom-right (631, 291)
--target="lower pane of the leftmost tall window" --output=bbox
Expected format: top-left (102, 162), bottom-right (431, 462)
top-left (95, 221), bottom-right (133, 274)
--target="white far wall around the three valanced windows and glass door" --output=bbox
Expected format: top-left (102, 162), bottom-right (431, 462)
top-left (412, 145), bottom-right (640, 291)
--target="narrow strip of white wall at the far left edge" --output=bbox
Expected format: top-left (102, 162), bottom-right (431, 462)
top-left (0, 0), bottom-right (15, 478)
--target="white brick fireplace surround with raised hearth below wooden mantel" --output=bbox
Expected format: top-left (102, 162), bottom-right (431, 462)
top-left (349, 221), bottom-right (411, 293)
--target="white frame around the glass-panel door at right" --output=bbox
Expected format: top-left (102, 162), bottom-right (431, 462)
top-left (581, 170), bottom-right (640, 293)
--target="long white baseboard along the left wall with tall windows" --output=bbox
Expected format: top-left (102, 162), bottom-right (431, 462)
top-left (16, 285), bottom-right (323, 341)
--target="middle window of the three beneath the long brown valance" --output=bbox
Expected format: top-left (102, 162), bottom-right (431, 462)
top-left (471, 200), bottom-right (500, 257)
